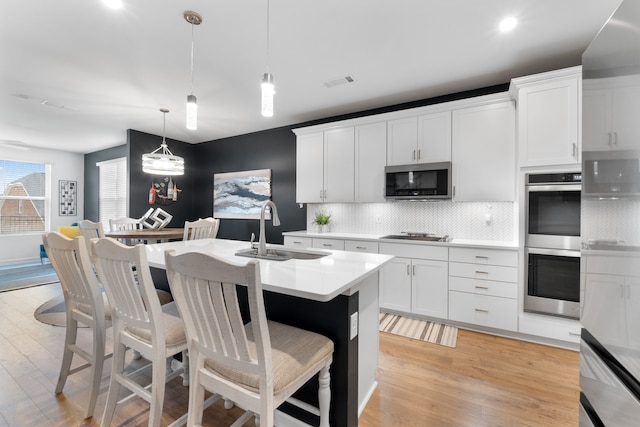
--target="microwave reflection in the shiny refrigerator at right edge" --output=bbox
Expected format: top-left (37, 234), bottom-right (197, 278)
top-left (582, 150), bottom-right (640, 198)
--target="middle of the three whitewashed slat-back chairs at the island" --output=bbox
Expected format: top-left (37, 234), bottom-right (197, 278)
top-left (93, 237), bottom-right (188, 427)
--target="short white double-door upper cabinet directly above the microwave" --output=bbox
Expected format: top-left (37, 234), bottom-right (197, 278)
top-left (387, 111), bottom-right (451, 166)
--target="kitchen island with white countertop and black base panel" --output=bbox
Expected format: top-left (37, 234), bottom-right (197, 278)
top-left (145, 239), bottom-right (393, 427)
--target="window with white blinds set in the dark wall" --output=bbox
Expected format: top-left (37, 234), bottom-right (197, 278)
top-left (96, 157), bottom-right (129, 230)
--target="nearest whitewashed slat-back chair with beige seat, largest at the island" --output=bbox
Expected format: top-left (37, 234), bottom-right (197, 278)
top-left (165, 250), bottom-right (333, 427)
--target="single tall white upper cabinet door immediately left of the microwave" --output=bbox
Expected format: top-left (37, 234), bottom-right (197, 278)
top-left (355, 122), bottom-right (387, 203)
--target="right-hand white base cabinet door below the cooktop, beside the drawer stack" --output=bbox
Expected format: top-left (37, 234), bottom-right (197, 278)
top-left (411, 259), bottom-right (449, 319)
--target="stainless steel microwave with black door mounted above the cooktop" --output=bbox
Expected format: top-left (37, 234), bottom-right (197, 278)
top-left (384, 162), bottom-right (451, 200)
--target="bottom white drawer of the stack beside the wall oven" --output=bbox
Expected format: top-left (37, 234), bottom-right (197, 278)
top-left (449, 291), bottom-right (518, 331)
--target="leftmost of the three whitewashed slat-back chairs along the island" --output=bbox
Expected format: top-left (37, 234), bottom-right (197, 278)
top-left (42, 232), bottom-right (111, 418)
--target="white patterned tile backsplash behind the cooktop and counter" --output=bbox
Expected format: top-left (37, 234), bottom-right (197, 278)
top-left (307, 201), bottom-right (517, 241)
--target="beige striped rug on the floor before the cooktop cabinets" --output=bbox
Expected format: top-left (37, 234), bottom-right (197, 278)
top-left (380, 313), bottom-right (458, 348)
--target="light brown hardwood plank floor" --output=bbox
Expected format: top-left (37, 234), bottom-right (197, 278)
top-left (0, 284), bottom-right (579, 427)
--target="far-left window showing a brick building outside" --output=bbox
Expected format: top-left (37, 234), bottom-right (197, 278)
top-left (0, 159), bottom-right (50, 234)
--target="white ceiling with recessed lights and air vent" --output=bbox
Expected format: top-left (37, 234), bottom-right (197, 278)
top-left (0, 0), bottom-right (621, 153)
